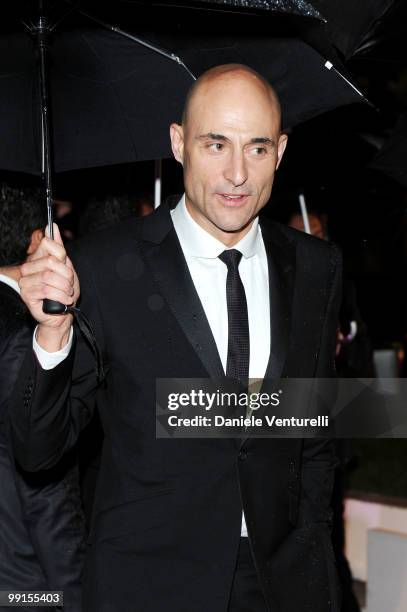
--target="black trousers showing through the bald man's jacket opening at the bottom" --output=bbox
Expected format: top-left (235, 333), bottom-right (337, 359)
top-left (228, 538), bottom-right (267, 612)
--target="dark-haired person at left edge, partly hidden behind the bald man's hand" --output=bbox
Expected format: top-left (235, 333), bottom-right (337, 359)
top-left (0, 184), bottom-right (85, 612)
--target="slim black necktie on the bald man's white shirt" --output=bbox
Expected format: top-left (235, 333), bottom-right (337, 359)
top-left (219, 249), bottom-right (250, 386)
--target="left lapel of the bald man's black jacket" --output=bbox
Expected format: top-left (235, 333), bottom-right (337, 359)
top-left (138, 205), bottom-right (225, 380)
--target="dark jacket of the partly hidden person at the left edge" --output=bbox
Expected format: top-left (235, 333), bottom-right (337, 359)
top-left (0, 282), bottom-right (85, 612)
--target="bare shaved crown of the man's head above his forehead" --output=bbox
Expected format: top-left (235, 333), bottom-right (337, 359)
top-left (182, 64), bottom-right (281, 129)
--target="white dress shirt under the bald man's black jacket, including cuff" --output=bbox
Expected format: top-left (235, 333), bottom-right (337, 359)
top-left (34, 196), bottom-right (270, 536)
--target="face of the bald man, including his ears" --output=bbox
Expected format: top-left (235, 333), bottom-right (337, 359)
top-left (171, 74), bottom-right (287, 246)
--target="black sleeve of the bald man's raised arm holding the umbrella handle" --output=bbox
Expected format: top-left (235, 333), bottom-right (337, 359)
top-left (9, 250), bottom-right (102, 471)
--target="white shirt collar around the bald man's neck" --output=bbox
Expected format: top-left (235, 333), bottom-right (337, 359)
top-left (171, 194), bottom-right (261, 259)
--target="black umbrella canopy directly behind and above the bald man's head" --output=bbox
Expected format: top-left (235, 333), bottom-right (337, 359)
top-left (0, 4), bottom-right (368, 174)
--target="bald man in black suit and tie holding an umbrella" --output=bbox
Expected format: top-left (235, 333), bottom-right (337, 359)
top-left (13, 65), bottom-right (340, 612)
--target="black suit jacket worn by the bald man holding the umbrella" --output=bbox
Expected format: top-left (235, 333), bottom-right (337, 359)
top-left (9, 205), bottom-right (341, 612)
